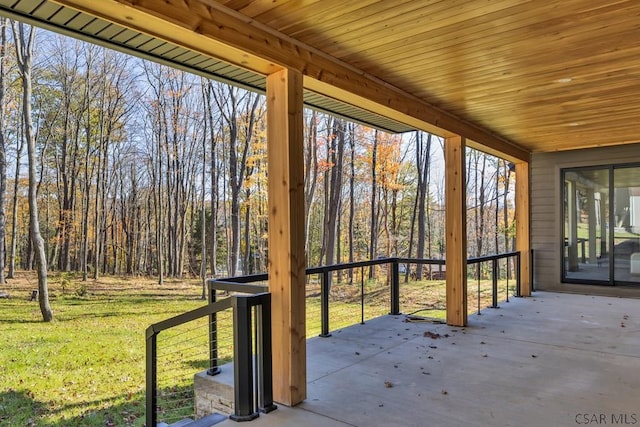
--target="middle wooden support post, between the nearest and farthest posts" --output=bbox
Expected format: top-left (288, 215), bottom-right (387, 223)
top-left (445, 136), bottom-right (467, 326)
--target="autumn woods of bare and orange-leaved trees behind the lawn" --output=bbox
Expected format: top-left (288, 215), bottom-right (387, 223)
top-left (0, 21), bottom-right (513, 318)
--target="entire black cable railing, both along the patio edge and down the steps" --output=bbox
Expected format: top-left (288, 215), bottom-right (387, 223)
top-left (146, 252), bottom-right (531, 426)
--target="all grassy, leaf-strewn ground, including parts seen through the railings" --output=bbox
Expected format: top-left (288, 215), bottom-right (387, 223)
top-left (0, 272), bottom-right (510, 427)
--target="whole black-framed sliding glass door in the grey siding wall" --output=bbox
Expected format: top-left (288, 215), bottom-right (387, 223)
top-left (562, 165), bottom-right (640, 285)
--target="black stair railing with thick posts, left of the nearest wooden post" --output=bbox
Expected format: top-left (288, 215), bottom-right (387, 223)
top-left (146, 282), bottom-right (276, 426)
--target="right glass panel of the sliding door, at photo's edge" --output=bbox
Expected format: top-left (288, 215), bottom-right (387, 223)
top-left (613, 167), bottom-right (640, 284)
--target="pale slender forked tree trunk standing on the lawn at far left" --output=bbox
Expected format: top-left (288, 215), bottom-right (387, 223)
top-left (13, 23), bottom-right (53, 322)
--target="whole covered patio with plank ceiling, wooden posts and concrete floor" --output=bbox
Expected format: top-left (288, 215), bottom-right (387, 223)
top-left (0, 0), bottom-right (640, 427)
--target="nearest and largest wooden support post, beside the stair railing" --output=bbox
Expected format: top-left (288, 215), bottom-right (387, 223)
top-left (267, 69), bottom-right (307, 406)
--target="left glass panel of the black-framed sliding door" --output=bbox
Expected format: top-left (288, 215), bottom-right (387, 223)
top-left (562, 167), bottom-right (608, 283)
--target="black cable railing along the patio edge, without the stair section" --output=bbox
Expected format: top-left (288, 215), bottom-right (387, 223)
top-left (205, 252), bottom-right (520, 342)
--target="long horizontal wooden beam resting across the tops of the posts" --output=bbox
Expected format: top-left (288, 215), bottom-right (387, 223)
top-left (53, 0), bottom-right (530, 161)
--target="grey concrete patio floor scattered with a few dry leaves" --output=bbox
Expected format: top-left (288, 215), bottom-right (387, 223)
top-left (218, 292), bottom-right (640, 427)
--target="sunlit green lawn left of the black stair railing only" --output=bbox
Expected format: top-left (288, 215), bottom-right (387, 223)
top-left (0, 278), bottom-right (203, 426)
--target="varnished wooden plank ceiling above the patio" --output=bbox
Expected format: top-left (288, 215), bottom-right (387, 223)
top-left (219, 0), bottom-right (640, 152)
